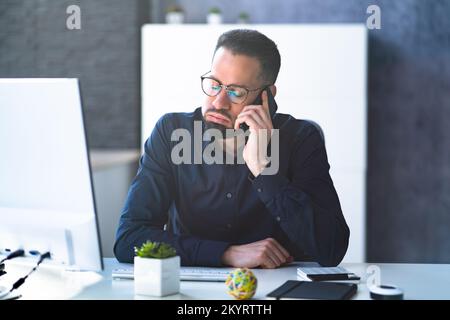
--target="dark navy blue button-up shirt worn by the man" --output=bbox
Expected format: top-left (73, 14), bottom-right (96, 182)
top-left (114, 108), bottom-right (350, 266)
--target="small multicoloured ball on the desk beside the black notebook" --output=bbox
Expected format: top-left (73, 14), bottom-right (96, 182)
top-left (225, 268), bottom-right (258, 300)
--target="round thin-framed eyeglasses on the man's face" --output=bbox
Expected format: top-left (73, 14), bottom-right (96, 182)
top-left (200, 71), bottom-right (266, 104)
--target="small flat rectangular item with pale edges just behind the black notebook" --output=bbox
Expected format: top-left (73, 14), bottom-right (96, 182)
top-left (297, 267), bottom-right (360, 283)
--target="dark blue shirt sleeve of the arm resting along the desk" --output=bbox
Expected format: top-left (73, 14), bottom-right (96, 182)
top-left (114, 115), bottom-right (230, 266)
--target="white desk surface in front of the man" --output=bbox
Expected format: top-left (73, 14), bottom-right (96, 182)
top-left (0, 258), bottom-right (450, 300)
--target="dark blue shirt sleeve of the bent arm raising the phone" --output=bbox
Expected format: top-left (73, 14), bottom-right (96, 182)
top-left (251, 125), bottom-right (350, 266)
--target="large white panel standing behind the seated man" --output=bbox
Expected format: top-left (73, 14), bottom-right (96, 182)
top-left (142, 24), bottom-right (367, 262)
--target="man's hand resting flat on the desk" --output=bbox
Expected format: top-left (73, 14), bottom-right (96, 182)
top-left (222, 238), bottom-right (293, 269)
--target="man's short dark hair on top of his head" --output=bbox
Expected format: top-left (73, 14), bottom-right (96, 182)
top-left (214, 29), bottom-right (281, 84)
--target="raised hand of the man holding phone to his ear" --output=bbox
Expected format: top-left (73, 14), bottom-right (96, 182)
top-left (234, 91), bottom-right (273, 177)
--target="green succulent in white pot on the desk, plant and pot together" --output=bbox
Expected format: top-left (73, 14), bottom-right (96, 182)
top-left (134, 241), bottom-right (180, 297)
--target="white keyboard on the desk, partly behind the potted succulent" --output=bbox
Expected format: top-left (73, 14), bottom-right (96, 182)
top-left (112, 267), bottom-right (233, 282)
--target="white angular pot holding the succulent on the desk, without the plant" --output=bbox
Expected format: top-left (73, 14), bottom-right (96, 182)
top-left (134, 256), bottom-right (180, 297)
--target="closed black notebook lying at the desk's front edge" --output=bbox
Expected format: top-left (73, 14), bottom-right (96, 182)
top-left (267, 280), bottom-right (358, 300)
